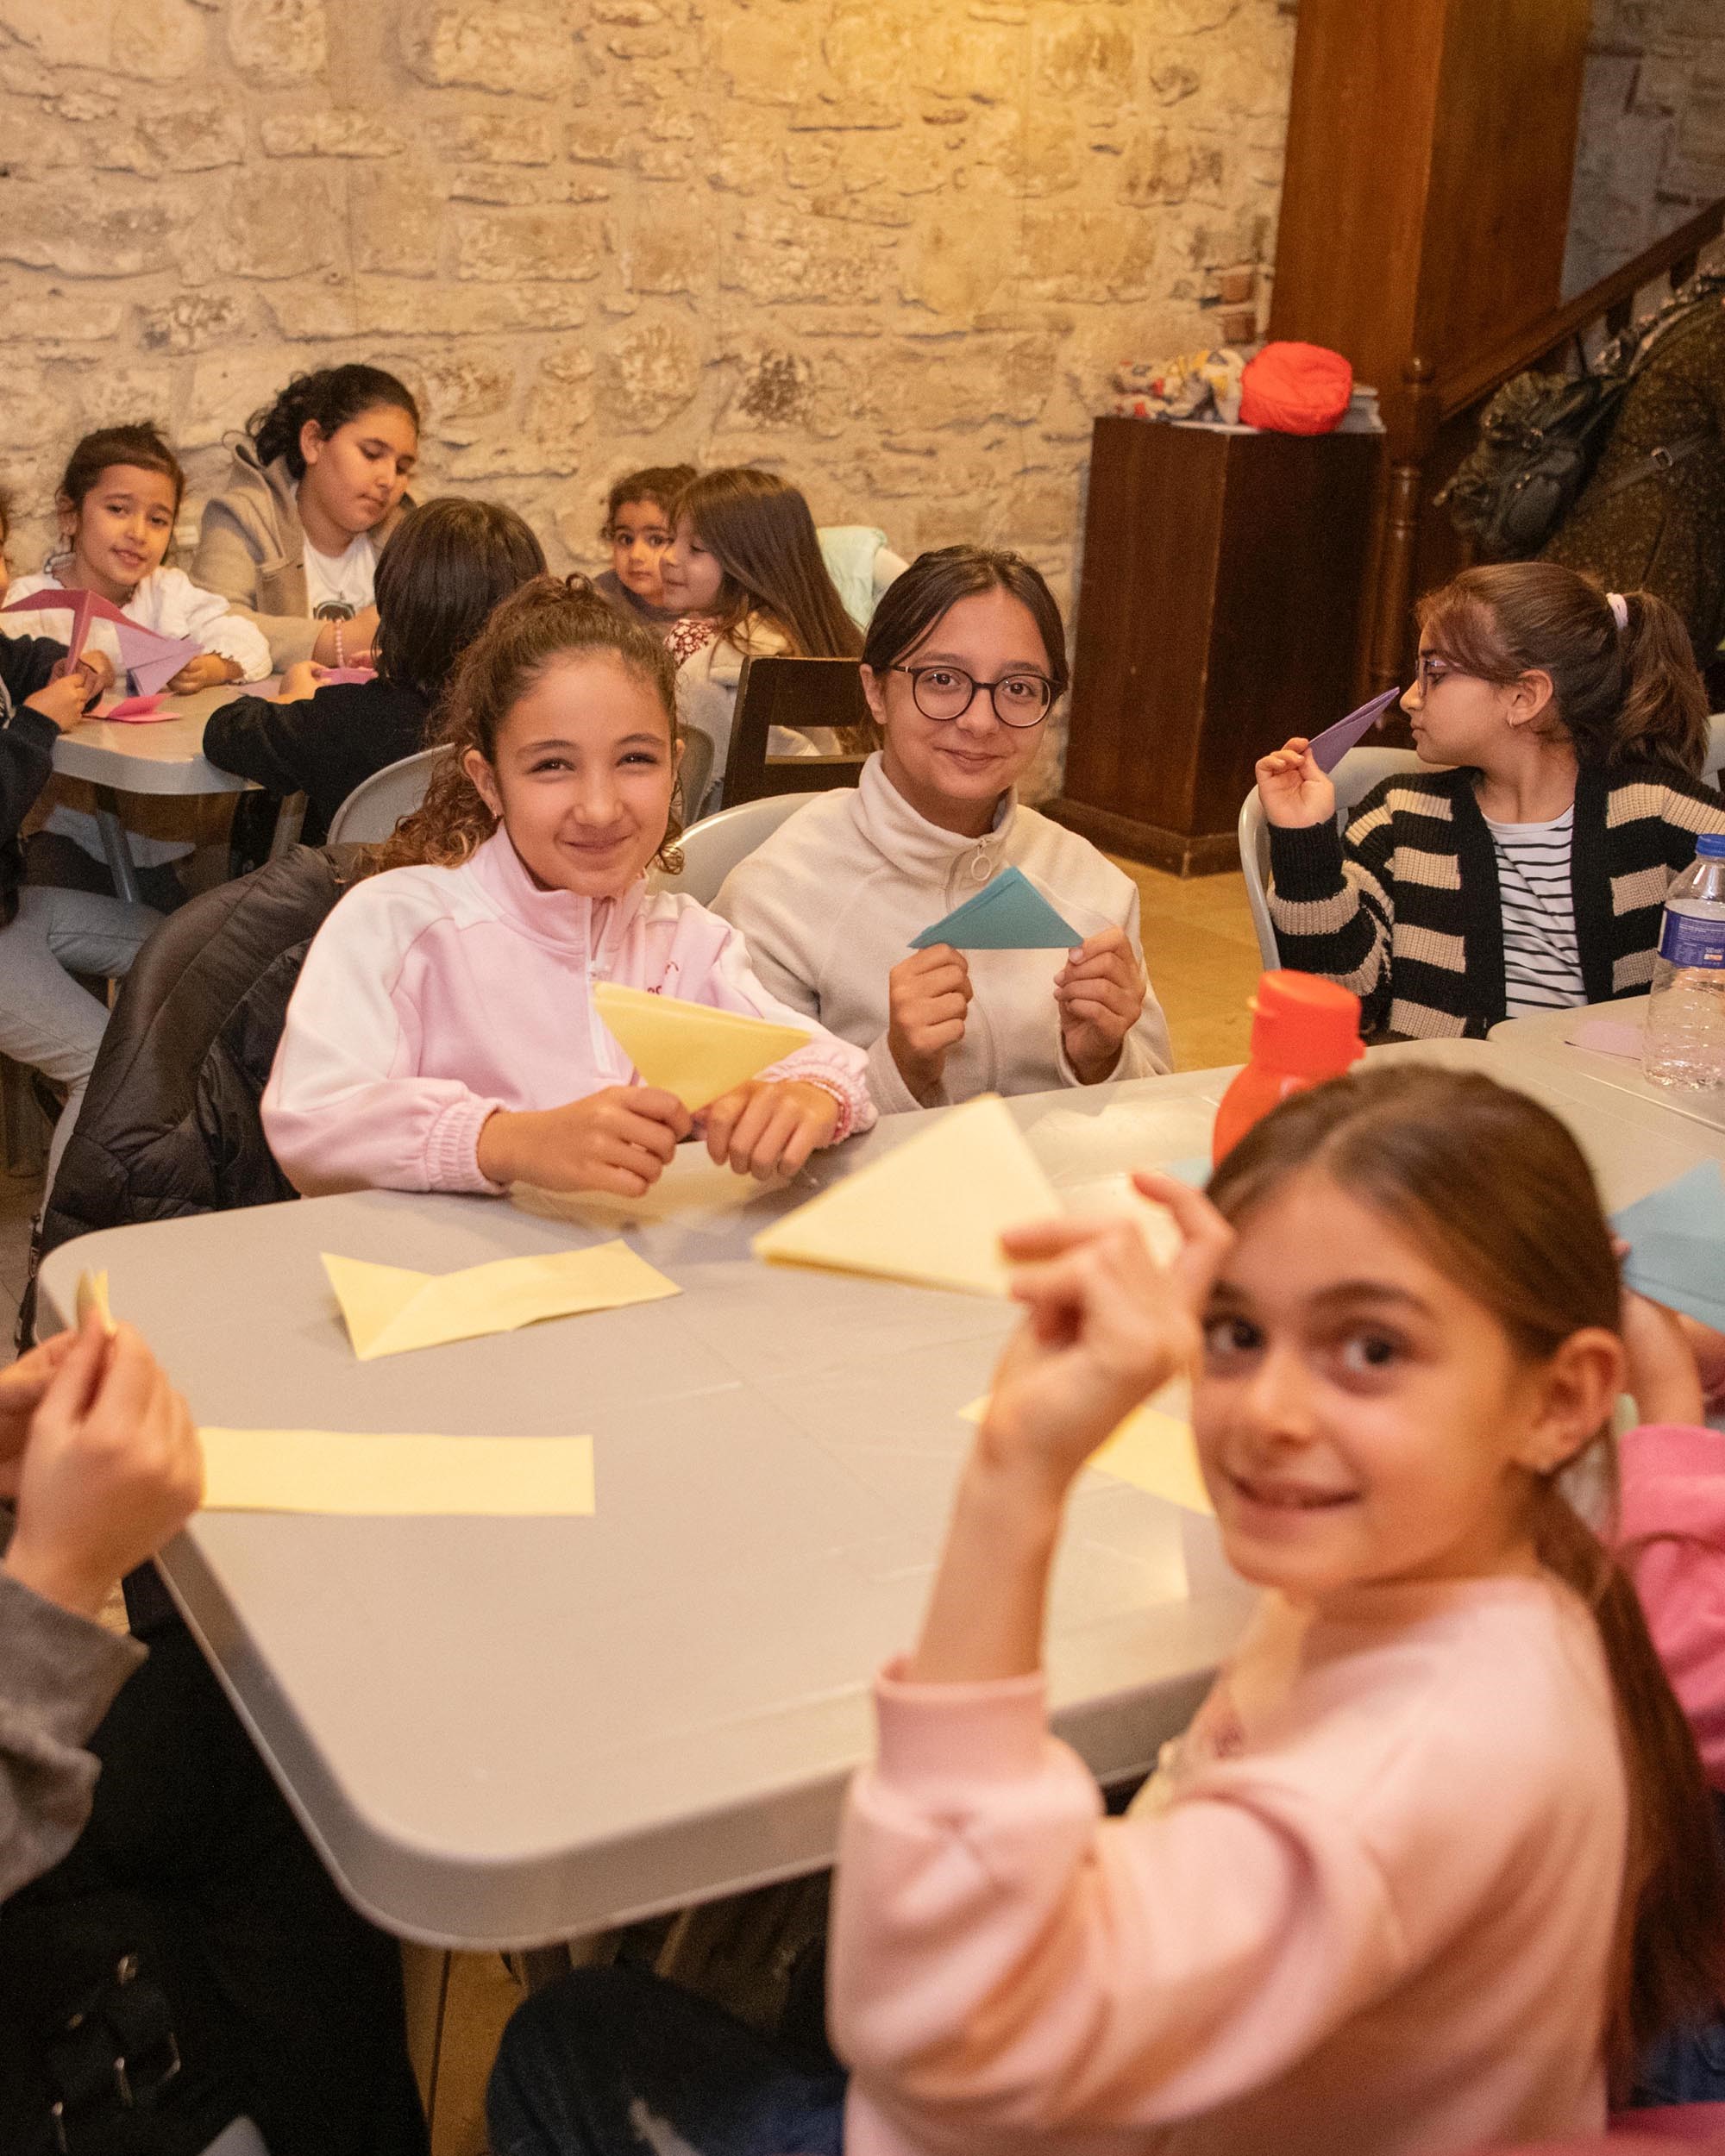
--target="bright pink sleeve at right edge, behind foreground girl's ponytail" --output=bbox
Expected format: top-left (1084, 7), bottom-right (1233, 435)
top-left (1617, 1423), bottom-right (1725, 1789)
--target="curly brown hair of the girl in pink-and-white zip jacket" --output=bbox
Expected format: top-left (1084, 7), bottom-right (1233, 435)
top-left (369, 578), bottom-right (681, 871)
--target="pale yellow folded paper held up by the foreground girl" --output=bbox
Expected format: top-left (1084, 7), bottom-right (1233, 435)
top-left (753, 1094), bottom-right (1061, 1296)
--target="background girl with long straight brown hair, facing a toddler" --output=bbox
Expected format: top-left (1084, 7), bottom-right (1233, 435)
top-left (660, 466), bottom-right (862, 806)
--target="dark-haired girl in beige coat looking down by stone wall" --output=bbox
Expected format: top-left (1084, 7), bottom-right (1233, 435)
top-left (192, 367), bottom-right (418, 668)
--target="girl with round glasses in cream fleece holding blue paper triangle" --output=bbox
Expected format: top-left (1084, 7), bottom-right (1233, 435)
top-left (714, 546), bottom-right (1171, 1111)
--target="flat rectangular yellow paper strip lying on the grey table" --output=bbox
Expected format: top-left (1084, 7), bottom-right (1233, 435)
top-left (198, 1430), bottom-right (593, 1520)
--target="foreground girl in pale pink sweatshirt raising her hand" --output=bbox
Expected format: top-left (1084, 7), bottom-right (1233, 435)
top-left (490, 1065), bottom-right (1725, 2156)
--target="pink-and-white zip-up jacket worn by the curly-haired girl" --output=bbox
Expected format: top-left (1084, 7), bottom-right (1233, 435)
top-left (263, 830), bottom-right (875, 1197)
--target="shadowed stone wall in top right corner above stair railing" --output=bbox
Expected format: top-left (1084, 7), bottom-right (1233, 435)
top-left (1564, 0), bottom-right (1725, 293)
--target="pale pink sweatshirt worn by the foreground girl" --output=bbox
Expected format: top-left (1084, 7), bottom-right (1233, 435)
top-left (828, 1578), bottom-right (1628, 2156)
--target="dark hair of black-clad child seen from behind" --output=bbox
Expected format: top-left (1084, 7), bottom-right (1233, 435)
top-left (378, 494), bottom-right (546, 701)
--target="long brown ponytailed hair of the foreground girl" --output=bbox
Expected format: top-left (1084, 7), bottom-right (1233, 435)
top-left (1210, 1065), bottom-right (1725, 2085)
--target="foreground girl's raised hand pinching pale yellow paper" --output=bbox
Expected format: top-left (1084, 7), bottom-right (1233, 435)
top-left (979, 1175), bottom-right (1233, 1492)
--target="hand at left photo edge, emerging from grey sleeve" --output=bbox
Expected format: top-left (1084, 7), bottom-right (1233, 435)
top-left (0, 1311), bottom-right (203, 1617)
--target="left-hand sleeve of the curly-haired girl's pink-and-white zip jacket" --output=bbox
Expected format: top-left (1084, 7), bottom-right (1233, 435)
top-left (261, 878), bottom-right (503, 1197)
